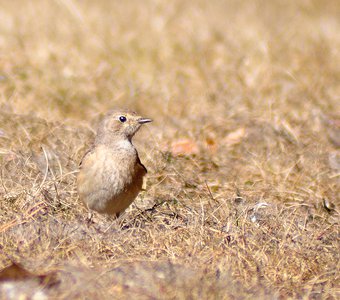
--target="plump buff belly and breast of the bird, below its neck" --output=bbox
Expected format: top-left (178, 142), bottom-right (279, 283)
top-left (78, 145), bottom-right (145, 215)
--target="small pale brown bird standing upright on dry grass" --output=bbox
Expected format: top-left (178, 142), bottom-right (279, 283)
top-left (77, 110), bottom-right (152, 217)
